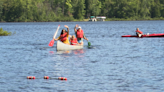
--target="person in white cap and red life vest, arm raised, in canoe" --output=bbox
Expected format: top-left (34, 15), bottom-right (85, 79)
top-left (74, 25), bottom-right (88, 45)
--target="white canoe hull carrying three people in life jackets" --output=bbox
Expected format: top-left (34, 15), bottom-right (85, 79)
top-left (56, 41), bottom-right (83, 51)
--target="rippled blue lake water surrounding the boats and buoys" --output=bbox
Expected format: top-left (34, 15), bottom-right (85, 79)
top-left (0, 21), bottom-right (164, 92)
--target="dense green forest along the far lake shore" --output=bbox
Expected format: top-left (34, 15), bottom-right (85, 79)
top-left (0, 0), bottom-right (164, 22)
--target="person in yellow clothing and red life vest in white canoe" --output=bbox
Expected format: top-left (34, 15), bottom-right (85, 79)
top-left (54, 25), bottom-right (70, 45)
